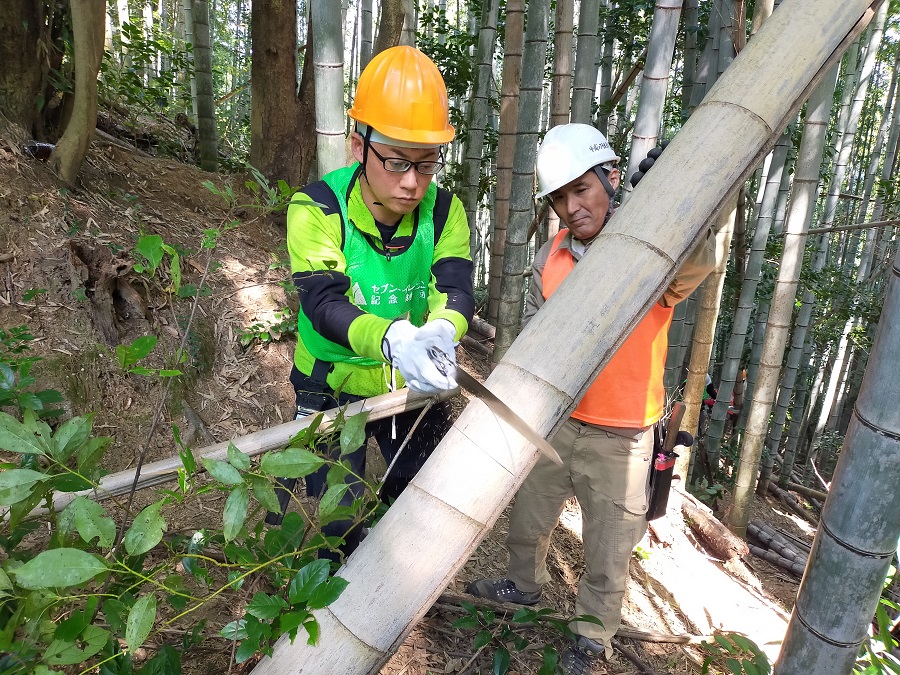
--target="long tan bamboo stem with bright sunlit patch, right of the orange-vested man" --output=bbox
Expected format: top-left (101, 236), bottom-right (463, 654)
top-left (728, 67), bottom-right (837, 537)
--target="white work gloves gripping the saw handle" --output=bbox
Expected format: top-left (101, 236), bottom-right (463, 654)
top-left (381, 319), bottom-right (457, 395)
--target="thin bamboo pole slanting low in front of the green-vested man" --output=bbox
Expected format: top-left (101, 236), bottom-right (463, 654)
top-left (40, 389), bottom-right (442, 514)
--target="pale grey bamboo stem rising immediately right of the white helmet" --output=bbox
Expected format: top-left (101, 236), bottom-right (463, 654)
top-left (622, 0), bottom-right (682, 195)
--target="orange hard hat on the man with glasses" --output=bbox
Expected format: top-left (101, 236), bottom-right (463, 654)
top-left (349, 46), bottom-right (456, 145)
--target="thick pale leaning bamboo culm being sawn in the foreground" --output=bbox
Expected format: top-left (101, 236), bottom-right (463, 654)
top-left (253, 0), bottom-right (870, 675)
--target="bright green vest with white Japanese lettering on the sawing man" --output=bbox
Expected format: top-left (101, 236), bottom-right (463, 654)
top-left (297, 163), bottom-right (437, 366)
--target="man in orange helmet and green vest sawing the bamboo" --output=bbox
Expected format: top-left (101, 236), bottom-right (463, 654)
top-left (267, 47), bottom-right (475, 560)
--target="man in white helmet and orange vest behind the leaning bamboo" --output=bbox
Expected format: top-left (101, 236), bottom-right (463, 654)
top-left (468, 124), bottom-right (715, 675)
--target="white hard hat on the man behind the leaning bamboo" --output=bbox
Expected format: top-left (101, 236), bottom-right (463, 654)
top-left (537, 122), bottom-right (619, 199)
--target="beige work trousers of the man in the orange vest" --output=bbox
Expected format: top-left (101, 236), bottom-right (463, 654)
top-left (506, 418), bottom-right (653, 645)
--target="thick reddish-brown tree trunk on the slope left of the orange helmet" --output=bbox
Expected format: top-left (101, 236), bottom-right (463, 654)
top-left (250, 0), bottom-right (316, 186)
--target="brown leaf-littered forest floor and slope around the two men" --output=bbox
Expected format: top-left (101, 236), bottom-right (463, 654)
top-left (0, 133), bottom-right (812, 675)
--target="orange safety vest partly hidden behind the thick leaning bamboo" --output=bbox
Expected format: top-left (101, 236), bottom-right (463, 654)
top-left (541, 230), bottom-right (673, 428)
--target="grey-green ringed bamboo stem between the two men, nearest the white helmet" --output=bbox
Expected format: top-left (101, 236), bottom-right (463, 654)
top-left (492, 0), bottom-right (550, 363)
